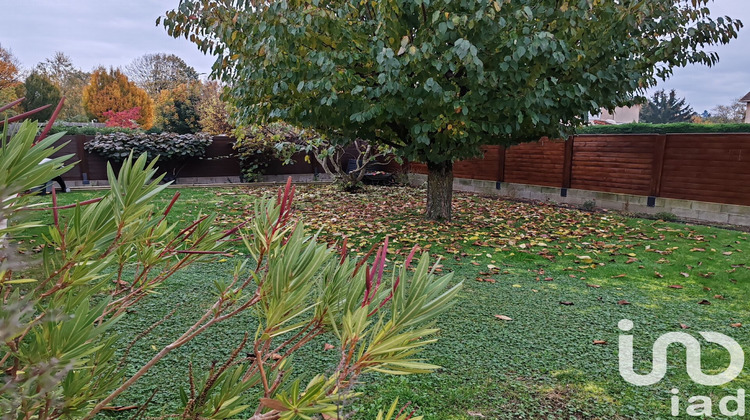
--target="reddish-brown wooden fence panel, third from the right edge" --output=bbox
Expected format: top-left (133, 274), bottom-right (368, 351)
top-left (505, 139), bottom-right (565, 187)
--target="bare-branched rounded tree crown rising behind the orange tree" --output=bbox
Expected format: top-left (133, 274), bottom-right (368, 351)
top-left (125, 53), bottom-right (198, 99)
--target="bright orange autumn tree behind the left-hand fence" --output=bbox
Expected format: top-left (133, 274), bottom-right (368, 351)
top-left (83, 67), bottom-right (154, 130)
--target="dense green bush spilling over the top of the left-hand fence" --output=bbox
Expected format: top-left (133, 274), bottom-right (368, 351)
top-left (84, 132), bottom-right (213, 162)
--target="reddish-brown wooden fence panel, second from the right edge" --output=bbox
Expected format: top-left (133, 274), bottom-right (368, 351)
top-left (570, 134), bottom-right (655, 195)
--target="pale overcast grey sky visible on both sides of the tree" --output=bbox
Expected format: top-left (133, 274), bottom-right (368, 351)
top-left (0, 0), bottom-right (750, 113)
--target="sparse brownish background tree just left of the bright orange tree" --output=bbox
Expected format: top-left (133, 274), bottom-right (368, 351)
top-left (36, 51), bottom-right (91, 122)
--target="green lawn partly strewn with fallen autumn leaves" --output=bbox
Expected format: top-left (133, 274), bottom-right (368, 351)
top-left (19, 186), bottom-right (750, 419)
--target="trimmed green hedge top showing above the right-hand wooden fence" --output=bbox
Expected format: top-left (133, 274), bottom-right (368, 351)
top-left (576, 123), bottom-right (750, 134)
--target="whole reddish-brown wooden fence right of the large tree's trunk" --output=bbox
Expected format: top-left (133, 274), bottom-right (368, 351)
top-left (410, 133), bottom-right (750, 205)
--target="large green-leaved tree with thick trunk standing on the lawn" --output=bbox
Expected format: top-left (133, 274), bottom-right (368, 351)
top-left (164, 0), bottom-right (742, 219)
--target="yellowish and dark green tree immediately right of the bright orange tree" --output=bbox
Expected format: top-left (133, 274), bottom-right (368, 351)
top-left (154, 82), bottom-right (201, 134)
